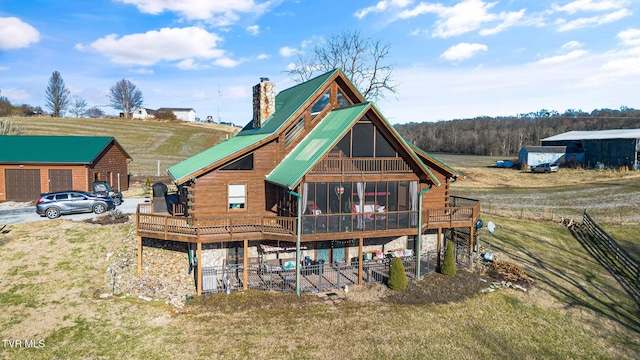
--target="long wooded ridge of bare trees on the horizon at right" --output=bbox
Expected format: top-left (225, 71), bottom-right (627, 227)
top-left (395, 106), bottom-right (640, 157)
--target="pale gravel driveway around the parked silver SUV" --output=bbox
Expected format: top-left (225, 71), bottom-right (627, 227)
top-left (0, 198), bottom-right (149, 227)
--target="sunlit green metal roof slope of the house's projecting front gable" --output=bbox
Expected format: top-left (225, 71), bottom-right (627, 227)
top-left (266, 103), bottom-right (370, 189)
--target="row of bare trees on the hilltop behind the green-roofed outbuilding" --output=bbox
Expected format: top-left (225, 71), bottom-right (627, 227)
top-left (0, 71), bottom-right (144, 118)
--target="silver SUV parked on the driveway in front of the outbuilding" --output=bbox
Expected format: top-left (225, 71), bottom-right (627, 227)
top-left (36, 191), bottom-right (115, 219)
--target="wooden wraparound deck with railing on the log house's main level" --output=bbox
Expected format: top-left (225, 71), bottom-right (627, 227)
top-left (136, 198), bottom-right (480, 243)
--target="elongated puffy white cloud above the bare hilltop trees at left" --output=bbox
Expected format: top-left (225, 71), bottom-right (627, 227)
top-left (76, 27), bottom-right (225, 66)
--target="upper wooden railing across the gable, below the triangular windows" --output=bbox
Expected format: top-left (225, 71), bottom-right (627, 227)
top-left (311, 158), bottom-right (412, 174)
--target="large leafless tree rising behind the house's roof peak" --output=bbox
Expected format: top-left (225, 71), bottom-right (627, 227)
top-left (286, 31), bottom-right (397, 100)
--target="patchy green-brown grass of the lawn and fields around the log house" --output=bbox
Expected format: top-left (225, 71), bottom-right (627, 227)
top-left (0, 119), bottom-right (640, 359)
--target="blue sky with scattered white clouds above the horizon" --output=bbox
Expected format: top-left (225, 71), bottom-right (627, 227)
top-left (0, 0), bottom-right (640, 124)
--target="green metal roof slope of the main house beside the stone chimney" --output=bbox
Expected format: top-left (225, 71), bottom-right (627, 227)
top-left (167, 69), bottom-right (339, 183)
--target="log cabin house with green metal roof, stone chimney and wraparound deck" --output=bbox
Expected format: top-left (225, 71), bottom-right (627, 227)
top-left (136, 69), bottom-right (480, 294)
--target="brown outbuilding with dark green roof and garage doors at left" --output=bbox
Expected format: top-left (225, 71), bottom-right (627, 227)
top-left (0, 135), bottom-right (132, 201)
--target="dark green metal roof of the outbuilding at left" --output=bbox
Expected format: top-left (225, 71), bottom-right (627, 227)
top-left (0, 135), bottom-right (125, 164)
